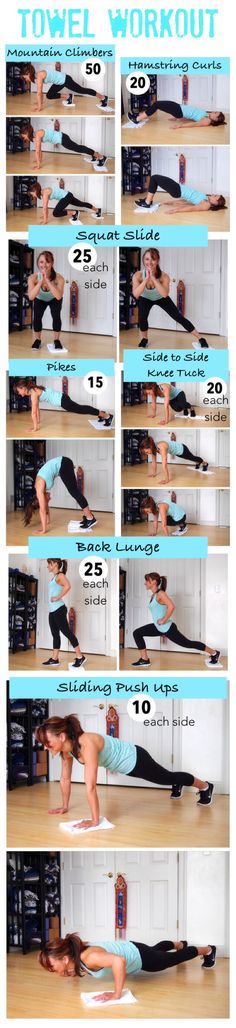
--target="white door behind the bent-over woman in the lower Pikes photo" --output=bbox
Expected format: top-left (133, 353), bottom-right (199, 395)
top-left (46, 439), bottom-right (114, 509)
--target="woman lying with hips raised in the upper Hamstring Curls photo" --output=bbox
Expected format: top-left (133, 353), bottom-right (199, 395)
top-left (128, 100), bottom-right (226, 129)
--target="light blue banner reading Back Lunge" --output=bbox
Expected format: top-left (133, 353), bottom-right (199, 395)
top-left (29, 535), bottom-right (208, 560)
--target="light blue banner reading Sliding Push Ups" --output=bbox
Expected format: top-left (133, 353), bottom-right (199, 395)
top-left (9, 671), bottom-right (228, 700)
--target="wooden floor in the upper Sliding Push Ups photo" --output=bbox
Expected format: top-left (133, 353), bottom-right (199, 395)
top-left (7, 781), bottom-right (229, 850)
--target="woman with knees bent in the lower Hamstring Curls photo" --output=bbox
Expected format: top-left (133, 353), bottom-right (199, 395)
top-left (134, 175), bottom-right (226, 214)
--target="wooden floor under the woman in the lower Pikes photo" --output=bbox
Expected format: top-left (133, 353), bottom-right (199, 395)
top-left (6, 507), bottom-right (115, 548)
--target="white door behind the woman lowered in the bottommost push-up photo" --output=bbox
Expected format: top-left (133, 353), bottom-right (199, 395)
top-left (62, 850), bottom-right (178, 946)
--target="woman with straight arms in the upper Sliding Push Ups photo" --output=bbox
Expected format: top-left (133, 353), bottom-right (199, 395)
top-left (36, 714), bottom-right (213, 829)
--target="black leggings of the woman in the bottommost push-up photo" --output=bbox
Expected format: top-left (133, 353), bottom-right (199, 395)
top-left (133, 940), bottom-right (198, 971)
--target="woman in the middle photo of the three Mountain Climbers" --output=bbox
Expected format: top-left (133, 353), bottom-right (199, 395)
top-left (19, 119), bottom-right (107, 172)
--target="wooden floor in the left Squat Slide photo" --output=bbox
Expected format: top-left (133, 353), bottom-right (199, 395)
top-left (9, 329), bottom-right (116, 361)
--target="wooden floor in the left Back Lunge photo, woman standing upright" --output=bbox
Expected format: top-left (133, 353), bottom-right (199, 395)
top-left (9, 650), bottom-right (117, 675)
